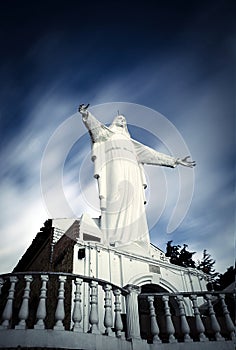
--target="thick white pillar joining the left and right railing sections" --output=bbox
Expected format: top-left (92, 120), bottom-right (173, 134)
top-left (125, 284), bottom-right (141, 340)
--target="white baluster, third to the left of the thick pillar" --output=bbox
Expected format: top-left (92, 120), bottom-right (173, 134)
top-left (89, 281), bottom-right (100, 334)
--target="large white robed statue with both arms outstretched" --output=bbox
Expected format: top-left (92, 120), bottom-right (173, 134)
top-left (78, 104), bottom-right (195, 250)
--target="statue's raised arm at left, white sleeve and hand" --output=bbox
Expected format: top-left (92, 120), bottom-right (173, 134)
top-left (78, 104), bottom-right (111, 143)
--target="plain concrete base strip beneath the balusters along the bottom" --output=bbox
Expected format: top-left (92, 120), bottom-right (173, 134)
top-left (0, 329), bottom-right (235, 350)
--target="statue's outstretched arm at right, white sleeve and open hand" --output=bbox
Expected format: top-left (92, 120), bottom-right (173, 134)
top-left (132, 140), bottom-right (196, 168)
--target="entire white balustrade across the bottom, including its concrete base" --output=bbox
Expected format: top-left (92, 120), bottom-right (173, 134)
top-left (0, 272), bottom-right (235, 350)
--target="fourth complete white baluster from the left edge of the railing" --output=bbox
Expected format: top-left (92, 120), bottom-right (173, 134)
top-left (53, 276), bottom-right (66, 330)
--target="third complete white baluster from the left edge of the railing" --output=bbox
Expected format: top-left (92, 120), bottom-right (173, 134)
top-left (34, 275), bottom-right (48, 329)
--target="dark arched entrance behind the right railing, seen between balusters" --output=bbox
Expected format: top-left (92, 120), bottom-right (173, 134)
top-left (138, 283), bottom-right (178, 343)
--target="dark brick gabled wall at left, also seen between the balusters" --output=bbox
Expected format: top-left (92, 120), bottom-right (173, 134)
top-left (3, 220), bottom-right (79, 329)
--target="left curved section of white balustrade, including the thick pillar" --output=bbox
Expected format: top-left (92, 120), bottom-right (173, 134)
top-left (0, 272), bottom-right (140, 339)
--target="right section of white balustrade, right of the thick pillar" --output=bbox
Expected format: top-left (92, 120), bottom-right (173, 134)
top-left (139, 292), bottom-right (235, 343)
